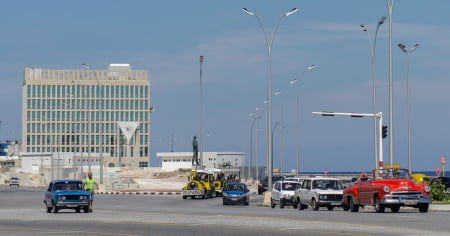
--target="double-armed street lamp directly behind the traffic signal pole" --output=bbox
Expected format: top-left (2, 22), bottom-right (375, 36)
top-left (360, 16), bottom-right (386, 168)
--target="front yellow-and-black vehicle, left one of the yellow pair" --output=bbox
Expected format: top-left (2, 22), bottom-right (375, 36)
top-left (182, 169), bottom-right (216, 199)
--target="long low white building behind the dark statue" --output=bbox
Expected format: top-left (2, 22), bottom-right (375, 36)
top-left (156, 152), bottom-right (245, 171)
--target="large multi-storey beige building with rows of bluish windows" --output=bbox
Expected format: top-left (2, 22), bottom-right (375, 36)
top-left (22, 64), bottom-right (152, 167)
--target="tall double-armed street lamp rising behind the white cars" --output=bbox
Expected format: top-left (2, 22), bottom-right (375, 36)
top-left (242, 8), bottom-right (298, 188)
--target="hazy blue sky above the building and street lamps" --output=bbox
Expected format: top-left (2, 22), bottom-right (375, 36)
top-left (0, 0), bottom-right (450, 172)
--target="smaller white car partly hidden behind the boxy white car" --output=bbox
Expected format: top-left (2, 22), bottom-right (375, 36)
top-left (270, 180), bottom-right (300, 208)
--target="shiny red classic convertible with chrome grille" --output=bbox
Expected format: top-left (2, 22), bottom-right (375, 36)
top-left (343, 168), bottom-right (431, 212)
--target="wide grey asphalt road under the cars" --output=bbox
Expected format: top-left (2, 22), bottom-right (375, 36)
top-left (0, 187), bottom-right (450, 236)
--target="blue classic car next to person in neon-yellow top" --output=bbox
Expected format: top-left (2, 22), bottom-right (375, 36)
top-left (44, 180), bottom-right (91, 213)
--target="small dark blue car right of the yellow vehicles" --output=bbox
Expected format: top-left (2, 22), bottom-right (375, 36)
top-left (222, 183), bottom-right (250, 206)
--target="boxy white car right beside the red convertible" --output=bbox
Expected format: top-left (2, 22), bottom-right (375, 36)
top-left (295, 176), bottom-right (346, 211)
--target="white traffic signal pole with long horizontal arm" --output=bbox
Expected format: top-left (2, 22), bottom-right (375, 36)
top-left (313, 112), bottom-right (384, 169)
